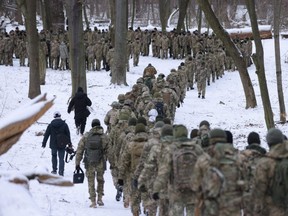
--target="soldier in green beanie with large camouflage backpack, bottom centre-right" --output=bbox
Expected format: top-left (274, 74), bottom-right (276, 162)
top-left (153, 125), bottom-right (203, 216)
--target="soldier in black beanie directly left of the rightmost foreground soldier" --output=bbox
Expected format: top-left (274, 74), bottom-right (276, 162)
top-left (241, 132), bottom-right (266, 216)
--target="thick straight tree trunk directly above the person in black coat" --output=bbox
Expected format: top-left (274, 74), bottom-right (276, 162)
top-left (66, 0), bottom-right (87, 95)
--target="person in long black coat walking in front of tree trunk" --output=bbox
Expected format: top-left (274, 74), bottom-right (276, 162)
top-left (68, 87), bottom-right (92, 135)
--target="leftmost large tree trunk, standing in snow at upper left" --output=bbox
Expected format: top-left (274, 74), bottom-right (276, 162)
top-left (17, 0), bottom-right (41, 99)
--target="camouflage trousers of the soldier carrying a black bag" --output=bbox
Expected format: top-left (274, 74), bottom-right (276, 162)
top-left (86, 162), bottom-right (105, 202)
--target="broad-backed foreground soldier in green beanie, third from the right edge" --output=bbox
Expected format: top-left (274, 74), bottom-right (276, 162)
top-left (192, 128), bottom-right (245, 216)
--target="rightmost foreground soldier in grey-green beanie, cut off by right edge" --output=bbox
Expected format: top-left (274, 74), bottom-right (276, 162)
top-left (252, 128), bottom-right (288, 216)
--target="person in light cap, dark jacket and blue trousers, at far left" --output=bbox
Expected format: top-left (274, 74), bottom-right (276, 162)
top-left (42, 111), bottom-right (71, 176)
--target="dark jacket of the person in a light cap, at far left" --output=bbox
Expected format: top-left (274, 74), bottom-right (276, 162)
top-left (42, 118), bottom-right (71, 148)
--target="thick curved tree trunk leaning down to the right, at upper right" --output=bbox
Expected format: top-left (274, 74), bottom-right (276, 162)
top-left (197, 0), bottom-right (257, 108)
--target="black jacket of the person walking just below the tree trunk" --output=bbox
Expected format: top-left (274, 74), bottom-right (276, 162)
top-left (67, 92), bottom-right (92, 119)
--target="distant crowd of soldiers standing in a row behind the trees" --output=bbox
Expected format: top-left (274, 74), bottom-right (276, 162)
top-left (0, 27), bottom-right (252, 75)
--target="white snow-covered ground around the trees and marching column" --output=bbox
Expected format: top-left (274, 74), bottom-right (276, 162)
top-left (0, 35), bottom-right (288, 216)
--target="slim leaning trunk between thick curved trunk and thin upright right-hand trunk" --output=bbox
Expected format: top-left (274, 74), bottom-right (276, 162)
top-left (246, 0), bottom-right (275, 129)
